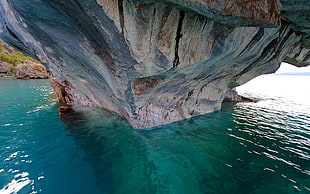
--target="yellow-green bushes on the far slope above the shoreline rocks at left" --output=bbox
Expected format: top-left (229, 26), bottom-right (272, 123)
top-left (0, 40), bottom-right (38, 66)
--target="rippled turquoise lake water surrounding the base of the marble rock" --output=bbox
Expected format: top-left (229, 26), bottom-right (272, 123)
top-left (0, 76), bottom-right (310, 194)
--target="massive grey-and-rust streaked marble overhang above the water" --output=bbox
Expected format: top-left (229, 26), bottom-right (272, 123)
top-left (0, 0), bottom-right (310, 128)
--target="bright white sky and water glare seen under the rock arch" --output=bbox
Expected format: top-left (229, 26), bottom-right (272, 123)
top-left (237, 62), bottom-right (310, 104)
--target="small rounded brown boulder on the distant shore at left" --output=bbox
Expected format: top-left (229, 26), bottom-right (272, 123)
top-left (15, 60), bottom-right (49, 79)
